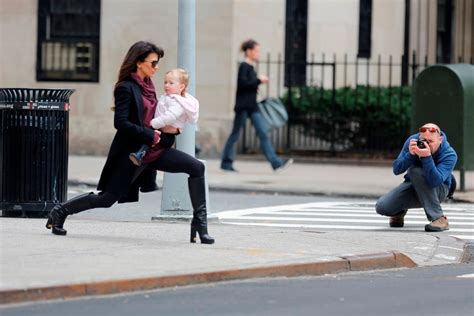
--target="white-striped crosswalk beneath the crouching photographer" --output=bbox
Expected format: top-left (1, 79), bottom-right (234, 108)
top-left (217, 202), bottom-right (474, 240)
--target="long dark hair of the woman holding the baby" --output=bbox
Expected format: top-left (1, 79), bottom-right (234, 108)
top-left (115, 41), bottom-right (165, 88)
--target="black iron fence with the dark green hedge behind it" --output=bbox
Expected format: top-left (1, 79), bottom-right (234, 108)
top-left (238, 54), bottom-right (473, 157)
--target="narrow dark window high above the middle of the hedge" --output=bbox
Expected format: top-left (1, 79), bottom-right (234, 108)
top-left (357, 0), bottom-right (372, 58)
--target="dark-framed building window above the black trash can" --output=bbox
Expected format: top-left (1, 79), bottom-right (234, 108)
top-left (36, 0), bottom-right (100, 82)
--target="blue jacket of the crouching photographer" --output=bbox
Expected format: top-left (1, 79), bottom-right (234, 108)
top-left (393, 132), bottom-right (458, 188)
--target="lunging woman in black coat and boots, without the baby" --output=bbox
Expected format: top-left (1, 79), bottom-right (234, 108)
top-left (46, 41), bottom-right (214, 244)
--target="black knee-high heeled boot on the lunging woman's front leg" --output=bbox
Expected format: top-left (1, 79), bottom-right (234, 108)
top-left (188, 177), bottom-right (214, 244)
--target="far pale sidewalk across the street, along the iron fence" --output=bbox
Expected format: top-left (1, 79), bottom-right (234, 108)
top-left (69, 156), bottom-right (474, 203)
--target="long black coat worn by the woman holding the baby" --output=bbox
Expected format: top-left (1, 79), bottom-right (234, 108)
top-left (97, 79), bottom-right (156, 203)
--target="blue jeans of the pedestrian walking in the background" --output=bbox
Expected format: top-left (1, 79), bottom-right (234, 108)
top-left (221, 111), bottom-right (283, 169)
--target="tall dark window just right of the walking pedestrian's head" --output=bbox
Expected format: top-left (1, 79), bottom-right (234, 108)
top-left (285, 0), bottom-right (308, 86)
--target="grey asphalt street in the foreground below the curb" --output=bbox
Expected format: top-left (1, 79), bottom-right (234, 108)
top-left (0, 264), bottom-right (474, 316)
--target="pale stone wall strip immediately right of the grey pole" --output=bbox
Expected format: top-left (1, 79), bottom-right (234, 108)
top-left (196, 0), bottom-right (235, 157)
